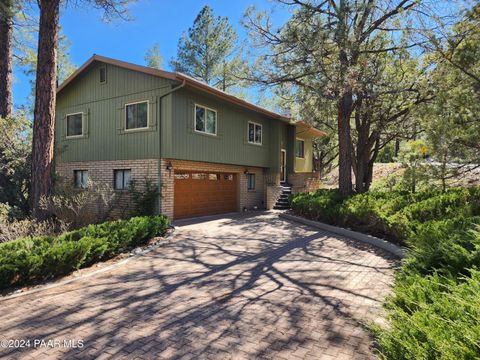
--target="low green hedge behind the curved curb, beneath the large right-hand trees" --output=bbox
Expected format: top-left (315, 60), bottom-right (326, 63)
top-left (290, 187), bottom-right (480, 244)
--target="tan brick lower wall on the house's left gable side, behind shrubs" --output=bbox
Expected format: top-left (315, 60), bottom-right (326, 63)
top-left (55, 159), bottom-right (158, 217)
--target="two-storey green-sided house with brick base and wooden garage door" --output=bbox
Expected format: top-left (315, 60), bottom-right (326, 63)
top-left (55, 55), bottom-right (324, 218)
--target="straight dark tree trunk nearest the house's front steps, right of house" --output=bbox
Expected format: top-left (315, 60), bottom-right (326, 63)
top-left (338, 90), bottom-right (353, 196)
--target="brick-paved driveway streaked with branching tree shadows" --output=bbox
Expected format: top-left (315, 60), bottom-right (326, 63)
top-left (0, 213), bottom-right (396, 359)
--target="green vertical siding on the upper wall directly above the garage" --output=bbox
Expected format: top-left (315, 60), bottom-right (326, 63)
top-left (162, 89), bottom-right (286, 167)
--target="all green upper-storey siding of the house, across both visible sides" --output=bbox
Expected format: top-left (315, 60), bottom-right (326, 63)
top-left (55, 62), bottom-right (294, 172)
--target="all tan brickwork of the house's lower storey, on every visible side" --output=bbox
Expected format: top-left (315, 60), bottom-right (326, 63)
top-left (55, 159), bottom-right (320, 218)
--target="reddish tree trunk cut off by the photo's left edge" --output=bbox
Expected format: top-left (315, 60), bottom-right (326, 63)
top-left (0, 0), bottom-right (13, 118)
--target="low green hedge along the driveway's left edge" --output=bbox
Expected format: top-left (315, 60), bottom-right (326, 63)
top-left (0, 216), bottom-right (169, 289)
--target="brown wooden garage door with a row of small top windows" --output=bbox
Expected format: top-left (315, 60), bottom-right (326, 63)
top-left (174, 170), bottom-right (238, 219)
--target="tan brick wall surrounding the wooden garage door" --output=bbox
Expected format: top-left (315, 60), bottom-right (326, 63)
top-left (160, 159), bottom-right (265, 218)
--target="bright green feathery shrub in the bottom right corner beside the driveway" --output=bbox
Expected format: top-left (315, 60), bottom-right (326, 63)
top-left (375, 270), bottom-right (480, 359)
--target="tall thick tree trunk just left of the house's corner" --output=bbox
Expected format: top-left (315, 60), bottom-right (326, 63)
top-left (30, 0), bottom-right (60, 219)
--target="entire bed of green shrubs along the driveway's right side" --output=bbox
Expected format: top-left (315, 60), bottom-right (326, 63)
top-left (291, 187), bottom-right (480, 359)
